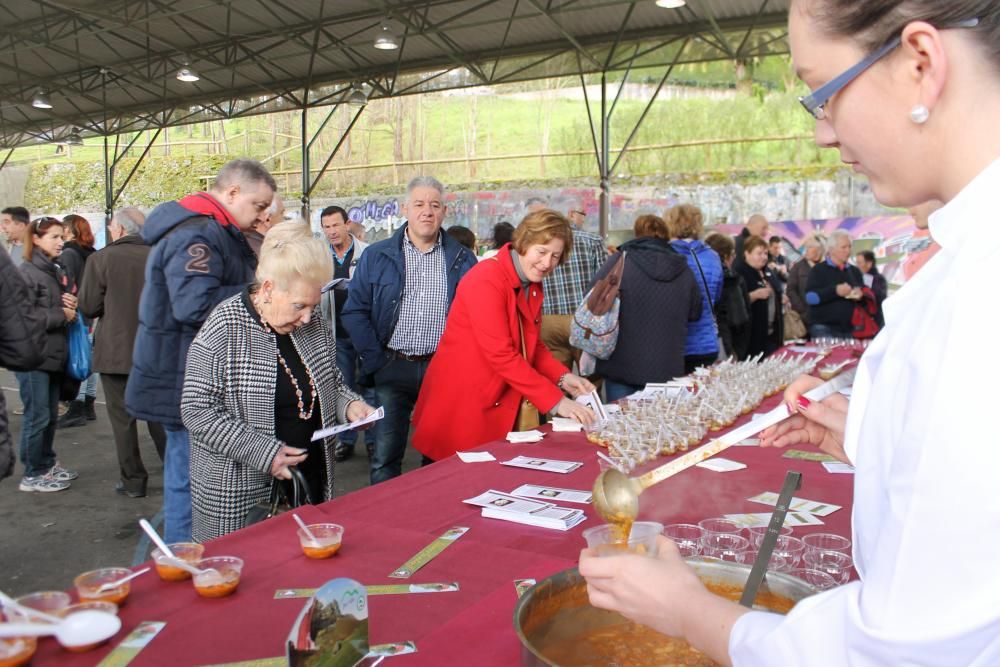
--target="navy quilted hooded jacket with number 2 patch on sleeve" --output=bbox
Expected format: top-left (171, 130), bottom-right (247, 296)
top-left (125, 202), bottom-right (257, 429)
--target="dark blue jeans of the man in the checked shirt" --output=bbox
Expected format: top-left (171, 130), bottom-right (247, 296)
top-left (371, 359), bottom-right (430, 484)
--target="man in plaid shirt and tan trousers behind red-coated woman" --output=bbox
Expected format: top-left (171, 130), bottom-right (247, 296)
top-left (540, 200), bottom-right (608, 368)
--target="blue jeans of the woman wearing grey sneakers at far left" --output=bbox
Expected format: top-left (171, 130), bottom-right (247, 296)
top-left (14, 371), bottom-right (62, 477)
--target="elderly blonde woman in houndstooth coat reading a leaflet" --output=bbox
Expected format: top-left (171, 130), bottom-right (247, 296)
top-left (181, 222), bottom-right (372, 542)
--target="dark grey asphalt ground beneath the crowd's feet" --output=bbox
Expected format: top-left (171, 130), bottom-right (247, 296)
top-left (0, 370), bottom-right (420, 596)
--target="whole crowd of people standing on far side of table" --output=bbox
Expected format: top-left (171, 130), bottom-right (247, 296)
top-left (3, 159), bottom-right (886, 541)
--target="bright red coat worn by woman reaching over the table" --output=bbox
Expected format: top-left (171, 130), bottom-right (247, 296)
top-left (413, 246), bottom-right (568, 460)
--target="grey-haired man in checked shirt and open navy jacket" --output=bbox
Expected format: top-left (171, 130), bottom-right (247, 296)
top-left (341, 176), bottom-right (476, 484)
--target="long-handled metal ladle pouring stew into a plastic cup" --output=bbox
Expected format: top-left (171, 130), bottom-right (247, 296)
top-left (594, 370), bottom-right (854, 523)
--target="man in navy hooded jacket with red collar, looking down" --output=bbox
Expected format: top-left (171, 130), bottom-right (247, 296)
top-left (125, 160), bottom-right (276, 544)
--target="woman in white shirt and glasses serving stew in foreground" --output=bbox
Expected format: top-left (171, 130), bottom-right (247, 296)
top-left (580, 0), bottom-right (1000, 666)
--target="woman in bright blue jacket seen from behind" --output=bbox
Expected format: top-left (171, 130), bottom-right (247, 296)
top-left (666, 204), bottom-right (722, 373)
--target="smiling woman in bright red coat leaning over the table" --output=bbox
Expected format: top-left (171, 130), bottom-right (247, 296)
top-left (413, 210), bottom-right (594, 461)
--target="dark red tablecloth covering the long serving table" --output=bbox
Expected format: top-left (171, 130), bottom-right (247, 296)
top-left (33, 358), bottom-right (853, 667)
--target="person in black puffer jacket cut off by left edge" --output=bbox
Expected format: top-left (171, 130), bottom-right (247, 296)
top-left (0, 243), bottom-right (45, 479)
